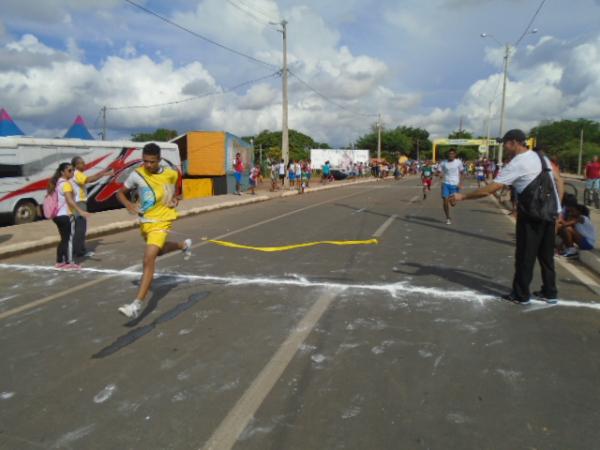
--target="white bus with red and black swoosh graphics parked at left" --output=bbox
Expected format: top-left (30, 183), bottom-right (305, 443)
top-left (0, 136), bottom-right (181, 224)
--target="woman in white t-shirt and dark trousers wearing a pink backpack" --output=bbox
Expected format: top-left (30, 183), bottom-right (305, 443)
top-left (48, 163), bottom-right (90, 269)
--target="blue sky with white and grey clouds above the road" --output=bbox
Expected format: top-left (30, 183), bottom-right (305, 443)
top-left (0, 0), bottom-right (600, 145)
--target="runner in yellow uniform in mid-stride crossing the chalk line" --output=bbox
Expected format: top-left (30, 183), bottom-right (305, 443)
top-left (117, 144), bottom-right (192, 319)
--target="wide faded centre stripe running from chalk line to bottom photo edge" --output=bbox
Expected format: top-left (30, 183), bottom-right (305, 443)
top-left (202, 290), bottom-right (340, 450)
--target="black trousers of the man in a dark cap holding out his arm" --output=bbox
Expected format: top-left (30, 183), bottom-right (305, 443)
top-left (512, 214), bottom-right (557, 301)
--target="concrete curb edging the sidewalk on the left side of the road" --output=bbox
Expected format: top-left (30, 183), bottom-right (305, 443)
top-left (0, 178), bottom-right (377, 259)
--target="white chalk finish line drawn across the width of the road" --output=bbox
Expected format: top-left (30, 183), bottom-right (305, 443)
top-left (0, 264), bottom-right (600, 312)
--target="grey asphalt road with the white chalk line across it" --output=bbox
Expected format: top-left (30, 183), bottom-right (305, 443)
top-left (0, 178), bottom-right (600, 450)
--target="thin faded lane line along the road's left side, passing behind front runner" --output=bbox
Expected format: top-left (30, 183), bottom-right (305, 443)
top-left (0, 185), bottom-right (371, 320)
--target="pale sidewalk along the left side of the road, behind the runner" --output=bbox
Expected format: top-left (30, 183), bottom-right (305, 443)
top-left (0, 177), bottom-right (376, 259)
